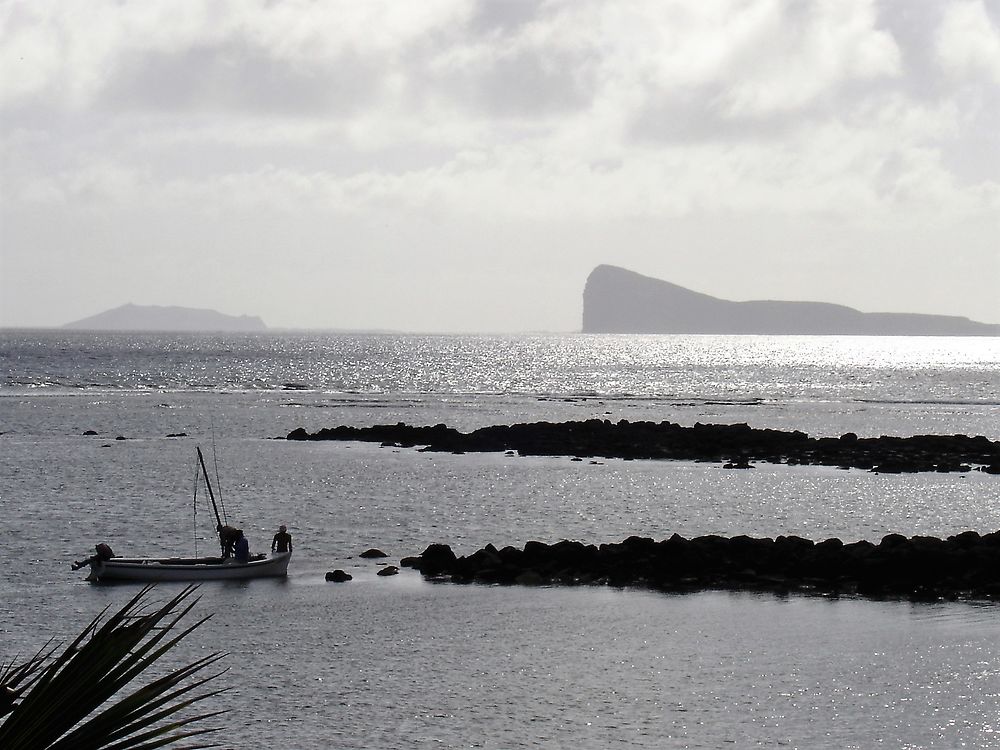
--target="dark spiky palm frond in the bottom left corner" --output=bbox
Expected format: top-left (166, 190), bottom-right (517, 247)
top-left (0, 586), bottom-right (226, 750)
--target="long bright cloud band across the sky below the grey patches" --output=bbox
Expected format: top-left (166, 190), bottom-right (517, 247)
top-left (11, 89), bottom-right (997, 224)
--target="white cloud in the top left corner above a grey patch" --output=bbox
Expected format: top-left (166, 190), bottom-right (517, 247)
top-left (0, 0), bottom-right (468, 107)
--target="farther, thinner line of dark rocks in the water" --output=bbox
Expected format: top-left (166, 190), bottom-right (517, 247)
top-left (288, 419), bottom-right (1000, 474)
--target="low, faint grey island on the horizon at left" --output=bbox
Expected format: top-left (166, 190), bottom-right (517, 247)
top-left (63, 303), bottom-right (267, 333)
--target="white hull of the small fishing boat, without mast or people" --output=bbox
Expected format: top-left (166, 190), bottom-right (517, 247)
top-left (87, 552), bottom-right (292, 583)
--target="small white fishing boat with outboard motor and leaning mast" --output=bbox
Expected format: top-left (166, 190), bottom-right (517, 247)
top-left (73, 448), bottom-right (292, 583)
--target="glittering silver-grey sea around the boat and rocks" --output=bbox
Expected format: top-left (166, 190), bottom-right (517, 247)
top-left (0, 331), bottom-right (1000, 748)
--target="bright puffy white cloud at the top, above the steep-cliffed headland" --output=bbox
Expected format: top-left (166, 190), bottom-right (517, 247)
top-left (534, 0), bottom-right (900, 122)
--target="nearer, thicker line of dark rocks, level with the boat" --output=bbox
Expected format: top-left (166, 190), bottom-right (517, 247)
top-left (401, 531), bottom-right (1000, 599)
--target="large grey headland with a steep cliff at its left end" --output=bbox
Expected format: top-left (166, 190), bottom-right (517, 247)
top-left (582, 265), bottom-right (1000, 336)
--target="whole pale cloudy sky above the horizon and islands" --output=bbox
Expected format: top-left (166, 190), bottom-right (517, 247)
top-left (0, 0), bottom-right (1000, 332)
